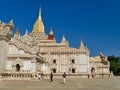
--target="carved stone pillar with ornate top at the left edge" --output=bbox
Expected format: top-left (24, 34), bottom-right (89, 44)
top-left (0, 20), bottom-right (14, 72)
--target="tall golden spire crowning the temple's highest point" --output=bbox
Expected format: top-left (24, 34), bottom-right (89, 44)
top-left (32, 8), bottom-right (44, 33)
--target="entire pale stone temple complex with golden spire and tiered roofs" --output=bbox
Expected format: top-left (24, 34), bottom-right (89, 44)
top-left (0, 10), bottom-right (110, 78)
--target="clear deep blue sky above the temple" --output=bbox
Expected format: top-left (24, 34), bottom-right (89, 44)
top-left (0, 0), bottom-right (120, 56)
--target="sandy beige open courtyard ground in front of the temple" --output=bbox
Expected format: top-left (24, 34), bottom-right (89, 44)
top-left (0, 77), bottom-right (120, 90)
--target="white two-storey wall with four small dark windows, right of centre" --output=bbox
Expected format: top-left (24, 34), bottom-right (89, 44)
top-left (51, 54), bottom-right (89, 73)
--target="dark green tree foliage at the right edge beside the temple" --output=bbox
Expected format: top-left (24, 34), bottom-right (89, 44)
top-left (108, 55), bottom-right (120, 76)
